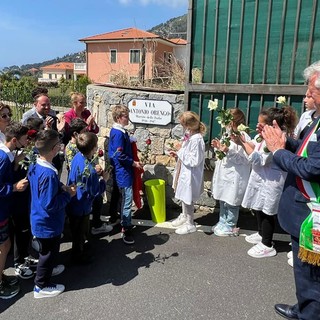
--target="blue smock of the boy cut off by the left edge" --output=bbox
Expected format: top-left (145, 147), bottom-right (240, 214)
top-left (0, 147), bottom-right (13, 222)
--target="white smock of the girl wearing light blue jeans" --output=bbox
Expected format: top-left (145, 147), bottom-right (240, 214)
top-left (211, 133), bottom-right (251, 206)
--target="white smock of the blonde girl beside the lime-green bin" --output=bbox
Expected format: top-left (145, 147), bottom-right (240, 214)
top-left (173, 133), bottom-right (205, 205)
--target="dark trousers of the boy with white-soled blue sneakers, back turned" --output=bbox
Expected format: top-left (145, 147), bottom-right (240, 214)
top-left (34, 236), bottom-right (60, 289)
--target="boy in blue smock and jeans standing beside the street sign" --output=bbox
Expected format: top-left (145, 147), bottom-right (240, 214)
top-left (108, 105), bottom-right (142, 244)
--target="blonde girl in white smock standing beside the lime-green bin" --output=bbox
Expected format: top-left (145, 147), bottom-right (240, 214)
top-left (170, 111), bottom-right (206, 234)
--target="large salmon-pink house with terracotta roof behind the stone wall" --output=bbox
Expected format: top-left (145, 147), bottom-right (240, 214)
top-left (79, 28), bottom-right (186, 83)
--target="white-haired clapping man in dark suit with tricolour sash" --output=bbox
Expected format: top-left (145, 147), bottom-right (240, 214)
top-left (262, 61), bottom-right (320, 320)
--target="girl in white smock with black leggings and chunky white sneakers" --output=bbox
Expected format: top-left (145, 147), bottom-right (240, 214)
top-left (236, 106), bottom-right (296, 258)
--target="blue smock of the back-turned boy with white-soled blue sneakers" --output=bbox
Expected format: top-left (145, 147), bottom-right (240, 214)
top-left (28, 159), bottom-right (71, 238)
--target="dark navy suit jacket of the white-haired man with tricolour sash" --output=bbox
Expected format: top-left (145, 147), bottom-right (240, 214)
top-left (273, 118), bottom-right (320, 238)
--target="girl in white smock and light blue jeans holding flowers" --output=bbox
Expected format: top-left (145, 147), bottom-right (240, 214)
top-left (211, 108), bottom-right (251, 236)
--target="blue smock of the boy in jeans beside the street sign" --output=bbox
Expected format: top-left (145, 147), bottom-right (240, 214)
top-left (108, 126), bottom-right (133, 188)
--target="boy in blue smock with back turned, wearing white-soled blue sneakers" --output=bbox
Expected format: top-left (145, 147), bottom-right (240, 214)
top-left (28, 130), bottom-right (76, 298)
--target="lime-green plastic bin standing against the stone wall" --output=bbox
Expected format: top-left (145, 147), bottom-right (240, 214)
top-left (144, 179), bottom-right (166, 223)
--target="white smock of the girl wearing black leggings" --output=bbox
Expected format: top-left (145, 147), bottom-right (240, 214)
top-left (242, 136), bottom-right (287, 215)
